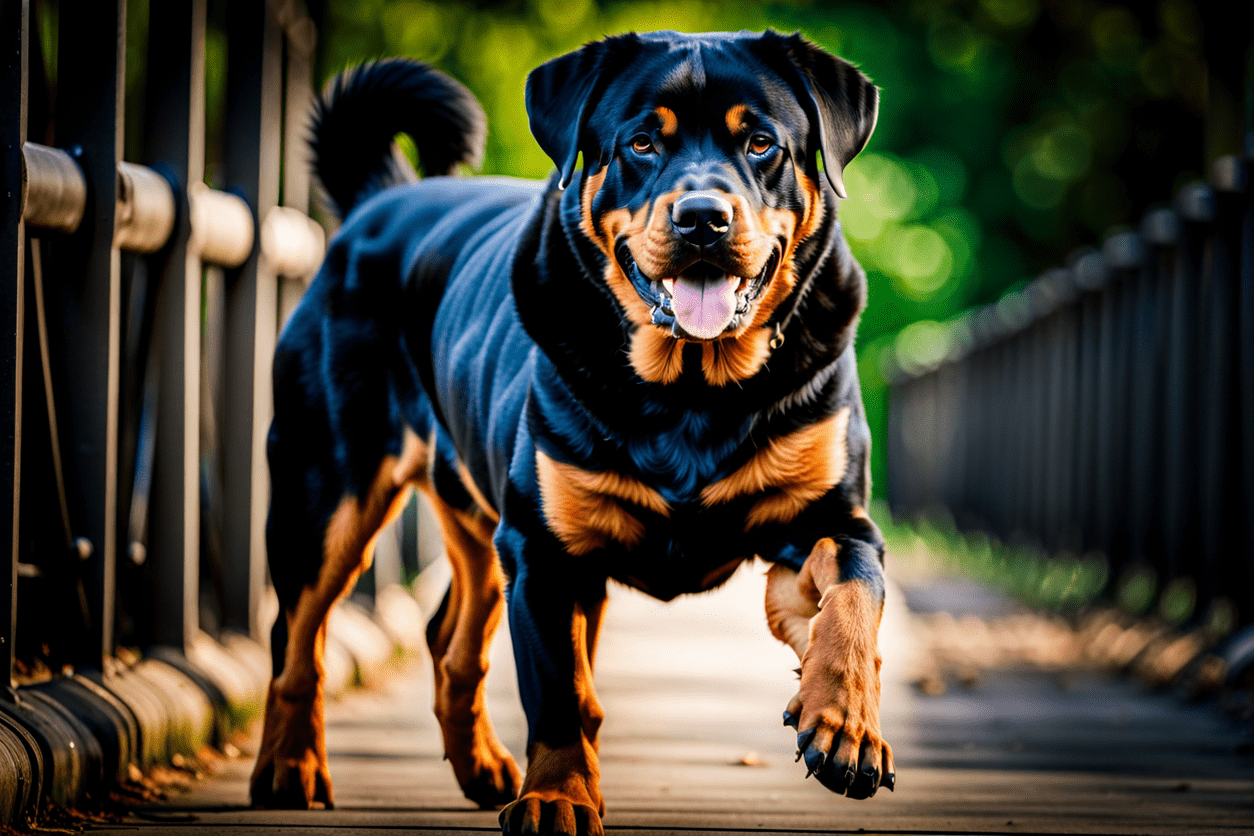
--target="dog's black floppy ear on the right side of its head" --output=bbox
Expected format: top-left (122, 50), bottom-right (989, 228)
top-left (762, 31), bottom-right (879, 197)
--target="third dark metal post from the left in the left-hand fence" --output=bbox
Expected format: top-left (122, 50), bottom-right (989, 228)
top-left (144, 0), bottom-right (206, 648)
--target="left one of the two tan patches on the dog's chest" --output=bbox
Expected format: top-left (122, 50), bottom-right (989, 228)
top-left (535, 451), bottom-right (671, 555)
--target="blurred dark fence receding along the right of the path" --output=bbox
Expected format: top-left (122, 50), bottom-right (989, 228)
top-left (888, 137), bottom-right (1254, 636)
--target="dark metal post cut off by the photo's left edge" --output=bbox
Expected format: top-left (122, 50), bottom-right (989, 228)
top-left (0, 0), bottom-right (29, 694)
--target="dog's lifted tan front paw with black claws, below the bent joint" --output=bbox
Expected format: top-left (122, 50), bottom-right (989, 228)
top-left (784, 584), bottom-right (897, 798)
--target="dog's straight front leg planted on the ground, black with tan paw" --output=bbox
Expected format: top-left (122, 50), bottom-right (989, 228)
top-left (497, 531), bottom-right (604, 836)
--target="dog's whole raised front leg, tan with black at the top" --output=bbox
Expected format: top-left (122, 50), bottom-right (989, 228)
top-left (766, 538), bottom-right (897, 798)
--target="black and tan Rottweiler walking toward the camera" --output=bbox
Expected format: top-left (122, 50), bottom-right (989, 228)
top-left (251, 31), bottom-right (895, 833)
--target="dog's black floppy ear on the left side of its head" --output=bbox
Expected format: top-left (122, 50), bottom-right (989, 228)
top-left (527, 33), bottom-right (640, 189)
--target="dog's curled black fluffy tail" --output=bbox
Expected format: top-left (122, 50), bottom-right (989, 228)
top-left (310, 58), bottom-right (487, 217)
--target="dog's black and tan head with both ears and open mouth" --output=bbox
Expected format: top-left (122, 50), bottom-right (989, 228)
top-left (527, 31), bottom-right (878, 355)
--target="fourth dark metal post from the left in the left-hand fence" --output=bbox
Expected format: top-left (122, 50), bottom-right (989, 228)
top-left (222, 0), bottom-right (283, 638)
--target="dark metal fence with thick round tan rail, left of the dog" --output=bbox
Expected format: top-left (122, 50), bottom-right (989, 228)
top-left (0, 0), bottom-right (431, 823)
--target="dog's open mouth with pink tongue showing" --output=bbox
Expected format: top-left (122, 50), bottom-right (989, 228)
top-left (614, 242), bottom-right (780, 341)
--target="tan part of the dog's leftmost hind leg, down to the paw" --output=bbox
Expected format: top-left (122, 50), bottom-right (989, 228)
top-left (250, 434), bottom-right (424, 808)
